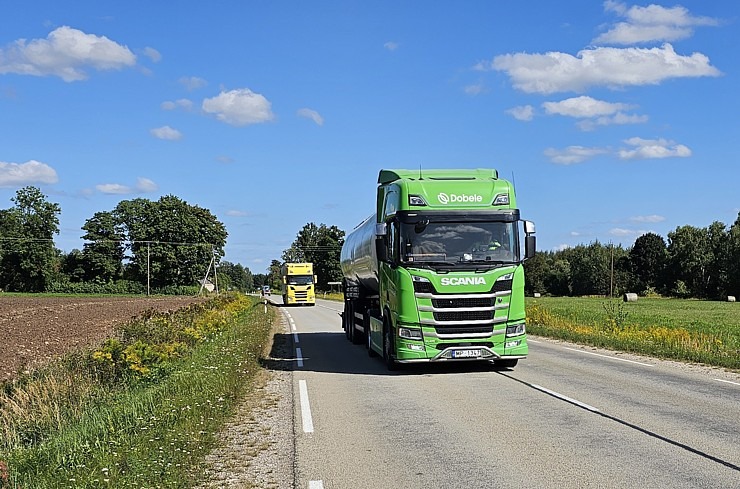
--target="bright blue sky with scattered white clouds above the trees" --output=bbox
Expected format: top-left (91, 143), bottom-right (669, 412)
top-left (0, 0), bottom-right (740, 273)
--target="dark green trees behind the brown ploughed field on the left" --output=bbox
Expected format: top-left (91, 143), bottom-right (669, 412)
top-left (0, 186), bottom-right (253, 293)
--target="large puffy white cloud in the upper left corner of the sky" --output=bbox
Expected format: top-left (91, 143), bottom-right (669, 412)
top-left (0, 26), bottom-right (136, 82)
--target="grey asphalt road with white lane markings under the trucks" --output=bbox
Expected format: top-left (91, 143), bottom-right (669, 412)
top-left (273, 297), bottom-right (740, 489)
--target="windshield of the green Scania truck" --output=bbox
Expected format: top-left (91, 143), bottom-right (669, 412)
top-left (400, 220), bottom-right (519, 267)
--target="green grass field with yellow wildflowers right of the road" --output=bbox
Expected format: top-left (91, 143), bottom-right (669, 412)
top-left (526, 297), bottom-right (740, 370)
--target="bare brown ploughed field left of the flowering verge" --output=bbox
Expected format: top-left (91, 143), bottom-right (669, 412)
top-left (0, 294), bottom-right (204, 382)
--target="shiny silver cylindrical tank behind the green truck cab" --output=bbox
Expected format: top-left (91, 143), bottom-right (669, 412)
top-left (340, 214), bottom-right (378, 292)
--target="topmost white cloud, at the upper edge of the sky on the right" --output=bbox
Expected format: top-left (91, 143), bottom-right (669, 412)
top-left (594, 1), bottom-right (719, 45)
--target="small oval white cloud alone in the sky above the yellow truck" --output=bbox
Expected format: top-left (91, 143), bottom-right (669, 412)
top-left (202, 88), bottom-right (275, 126)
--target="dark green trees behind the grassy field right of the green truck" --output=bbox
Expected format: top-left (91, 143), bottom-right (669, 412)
top-left (524, 213), bottom-right (740, 300)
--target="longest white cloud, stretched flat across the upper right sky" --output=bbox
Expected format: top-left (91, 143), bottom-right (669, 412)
top-left (488, 44), bottom-right (721, 94)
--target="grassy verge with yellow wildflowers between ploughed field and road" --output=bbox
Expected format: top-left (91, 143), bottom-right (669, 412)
top-left (0, 294), bottom-right (275, 489)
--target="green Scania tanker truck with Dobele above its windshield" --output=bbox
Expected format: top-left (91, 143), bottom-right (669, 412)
top-left (340, 169), bottom-right (536, 370)
